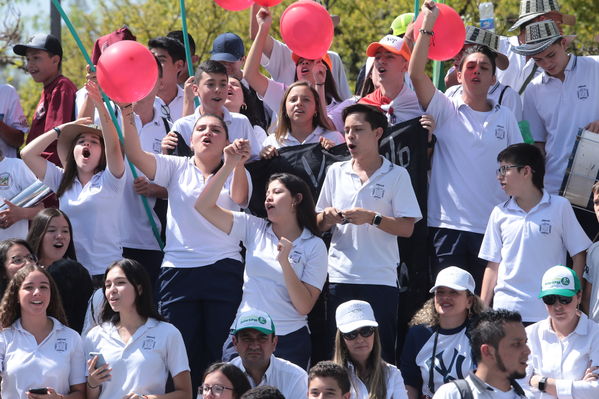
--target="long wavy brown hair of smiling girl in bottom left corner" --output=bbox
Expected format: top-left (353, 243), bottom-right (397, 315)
top-left (0, 265), bottom-right (68, 328)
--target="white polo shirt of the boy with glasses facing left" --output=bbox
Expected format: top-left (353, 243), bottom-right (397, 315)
top-left (478, 191), bottom-right (599, 324)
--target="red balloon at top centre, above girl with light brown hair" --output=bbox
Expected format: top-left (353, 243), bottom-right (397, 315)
top-left (280, 0), bottom-right (334, 60)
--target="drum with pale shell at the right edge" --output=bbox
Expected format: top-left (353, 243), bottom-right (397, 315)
top-left (560, 129), bottom-right (599, 214)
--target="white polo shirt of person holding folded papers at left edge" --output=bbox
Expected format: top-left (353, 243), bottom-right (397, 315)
top-left (0, 157), bottom-right (37, 240)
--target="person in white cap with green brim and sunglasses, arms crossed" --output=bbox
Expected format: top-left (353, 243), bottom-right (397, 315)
top-left (523, 266), bottom-right (599, 399)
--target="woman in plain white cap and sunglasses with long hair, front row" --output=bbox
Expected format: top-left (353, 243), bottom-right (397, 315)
top-left (333, 300), bottom-right (408, 399)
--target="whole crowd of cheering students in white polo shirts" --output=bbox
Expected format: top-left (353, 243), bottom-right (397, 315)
top-left (0, 0), bottom-right (599, 399)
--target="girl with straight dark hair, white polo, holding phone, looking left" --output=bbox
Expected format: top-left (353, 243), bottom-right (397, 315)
top-left (84, 259), bottom-right (192, 399)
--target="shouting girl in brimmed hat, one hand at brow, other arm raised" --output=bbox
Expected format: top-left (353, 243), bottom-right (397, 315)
top-left (21, 81), bottom-right (125, 285)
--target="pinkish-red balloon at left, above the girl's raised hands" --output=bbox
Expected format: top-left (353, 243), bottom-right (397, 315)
top-left (96, 40), bottom-right (158, 103)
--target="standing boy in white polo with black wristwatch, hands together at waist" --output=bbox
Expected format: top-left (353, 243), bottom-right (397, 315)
top-left (316, 104), bottom-right (422, 364)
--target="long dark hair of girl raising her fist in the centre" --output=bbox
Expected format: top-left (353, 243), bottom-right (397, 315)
top-left (266, 173), bottom-right (320, 237)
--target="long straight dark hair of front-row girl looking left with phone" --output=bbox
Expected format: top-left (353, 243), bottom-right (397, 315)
top-left (100, 258), bottom-right (164, 325)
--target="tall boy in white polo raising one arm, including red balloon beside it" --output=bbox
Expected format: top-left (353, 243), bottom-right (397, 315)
top-left (409, 0), bottom-right (522, 294)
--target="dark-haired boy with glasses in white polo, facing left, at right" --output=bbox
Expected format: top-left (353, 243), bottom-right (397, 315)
top-left (479, 143), bottom-right (591, 323)
